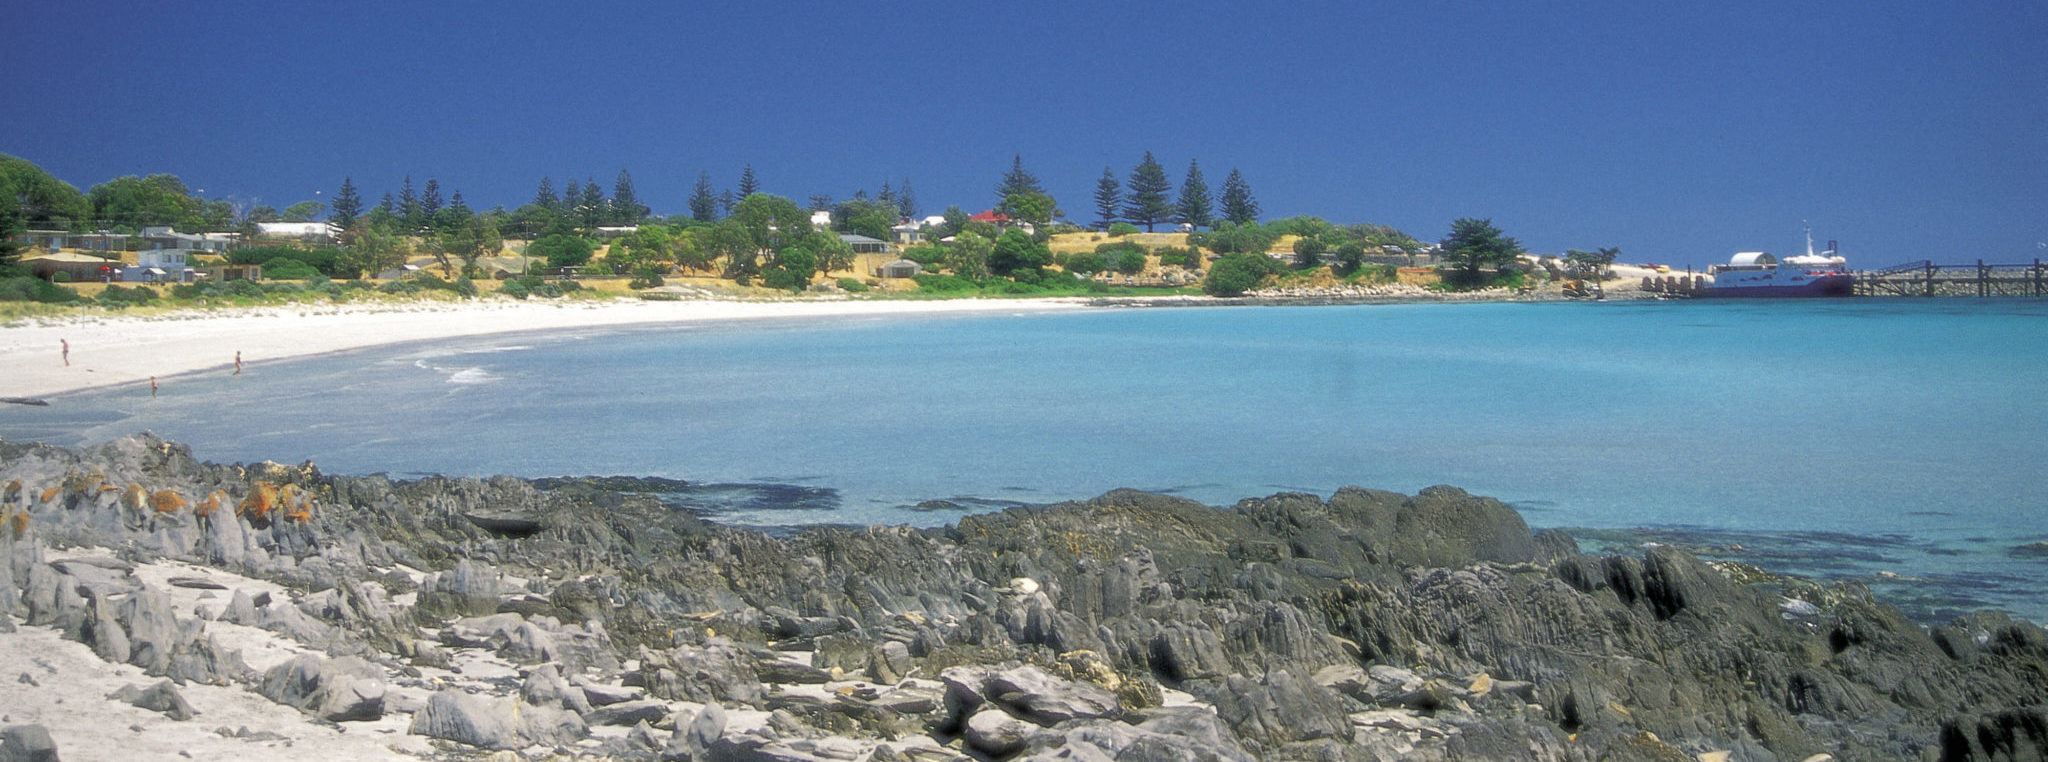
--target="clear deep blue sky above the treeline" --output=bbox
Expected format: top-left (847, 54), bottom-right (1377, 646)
top-left (0, 0), bottom-right (2048, 266)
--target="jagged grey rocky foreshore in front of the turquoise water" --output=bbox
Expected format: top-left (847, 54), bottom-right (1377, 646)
top-left (0, 434), bottom-right (2048, 760)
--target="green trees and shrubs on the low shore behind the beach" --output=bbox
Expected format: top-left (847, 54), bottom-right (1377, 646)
top-left (0, 152), bottom-right (1618, 315)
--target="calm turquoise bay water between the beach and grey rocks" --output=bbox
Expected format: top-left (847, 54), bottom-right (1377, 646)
top-left (0, 299), bottom-right (2048, 619)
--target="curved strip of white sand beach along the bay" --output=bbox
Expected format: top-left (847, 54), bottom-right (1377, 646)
top-left (0, 299), bottom-right (1083, 397)
